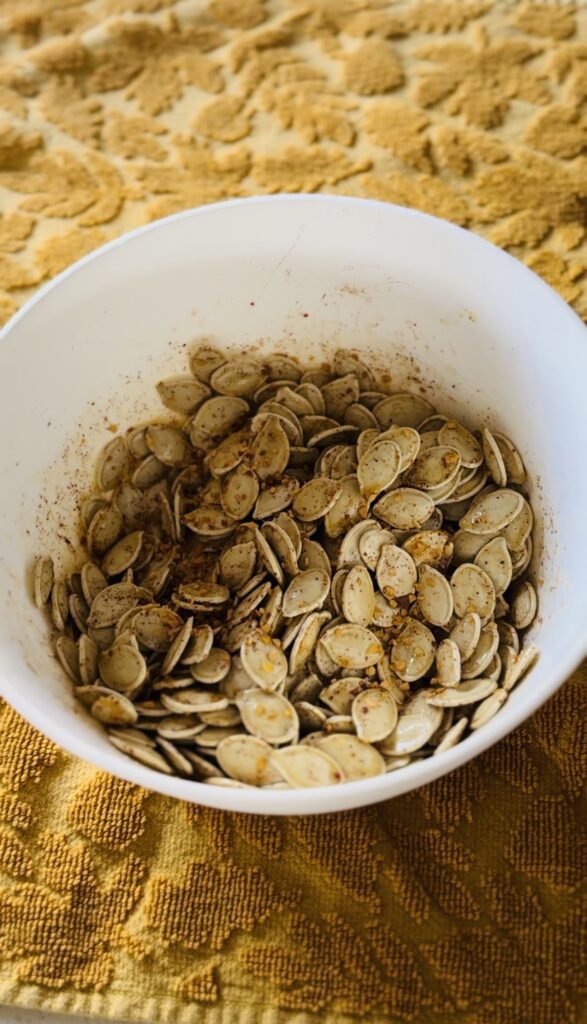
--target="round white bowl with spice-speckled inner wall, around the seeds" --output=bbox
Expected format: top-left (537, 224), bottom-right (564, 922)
top-left (0, 196), bottom-right (587, 814)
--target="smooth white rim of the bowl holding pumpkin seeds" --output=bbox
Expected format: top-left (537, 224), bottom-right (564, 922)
top-left (0, 193), bottom-right (587, 815)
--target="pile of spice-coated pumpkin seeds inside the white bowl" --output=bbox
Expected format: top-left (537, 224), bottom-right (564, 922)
top-left (34, 344), bottom-right (537, 788)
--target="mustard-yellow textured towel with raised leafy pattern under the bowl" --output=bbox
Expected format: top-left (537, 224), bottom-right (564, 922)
top-left (0, 0), bottom-right (587, 1024)
